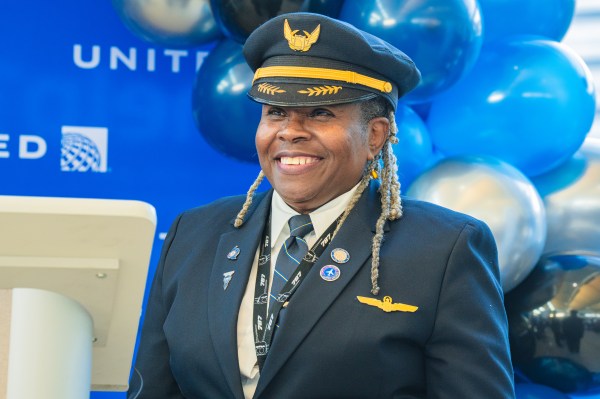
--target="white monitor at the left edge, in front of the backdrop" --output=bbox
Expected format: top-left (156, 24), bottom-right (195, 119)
top-left (0, 196), bottom-right (156, 391)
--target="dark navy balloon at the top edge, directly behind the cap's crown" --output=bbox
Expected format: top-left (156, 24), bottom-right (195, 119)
top-left (210, 0), bottom-right (343, 43)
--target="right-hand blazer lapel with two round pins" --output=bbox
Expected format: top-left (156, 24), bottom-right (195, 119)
top-left (254, 184), bottom-right (381, 398)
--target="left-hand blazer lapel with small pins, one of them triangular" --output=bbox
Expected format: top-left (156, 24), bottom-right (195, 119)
top-left (208, 191), bottom-right (271, 398)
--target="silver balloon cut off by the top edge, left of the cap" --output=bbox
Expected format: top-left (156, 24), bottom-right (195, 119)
top-left (113, 0), bottom-right (222, 47)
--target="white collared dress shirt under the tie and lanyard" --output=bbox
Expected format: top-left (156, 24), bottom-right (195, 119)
top-left (237, 185), bottom-right (358, 399)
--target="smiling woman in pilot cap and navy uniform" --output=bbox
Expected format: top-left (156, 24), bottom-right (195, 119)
top-left (130, 13), bottom-right (514, 399)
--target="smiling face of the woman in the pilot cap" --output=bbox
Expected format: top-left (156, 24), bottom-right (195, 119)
top-left (256, 103), bottom-right (380, 213)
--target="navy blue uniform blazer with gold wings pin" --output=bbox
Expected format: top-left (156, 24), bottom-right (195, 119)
top-left (128, 184), bottom-right (514, 399)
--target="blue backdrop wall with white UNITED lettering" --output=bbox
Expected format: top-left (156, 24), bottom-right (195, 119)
top-left (0, 0), bottom-right (259, 398)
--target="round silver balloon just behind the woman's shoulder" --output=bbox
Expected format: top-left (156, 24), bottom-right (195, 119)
top-left (407, 157), bottom-right (546, 292)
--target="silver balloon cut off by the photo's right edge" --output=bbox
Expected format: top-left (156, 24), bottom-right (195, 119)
top-left (532, 139), bottom-right (600, 256)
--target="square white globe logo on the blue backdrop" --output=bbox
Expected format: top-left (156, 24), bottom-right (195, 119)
top-left (60, 126), bottom-right (108, 172)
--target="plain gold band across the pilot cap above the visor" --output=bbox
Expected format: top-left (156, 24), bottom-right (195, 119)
top-left (252, 66), bottom-right (392, 93)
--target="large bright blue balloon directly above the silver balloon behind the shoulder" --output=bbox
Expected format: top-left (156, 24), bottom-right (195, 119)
top-left (427, 37), bottom-right (596, 176)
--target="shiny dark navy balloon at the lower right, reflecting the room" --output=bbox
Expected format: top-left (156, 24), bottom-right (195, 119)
top-left (505, 255), bottom-right (600, 393)
